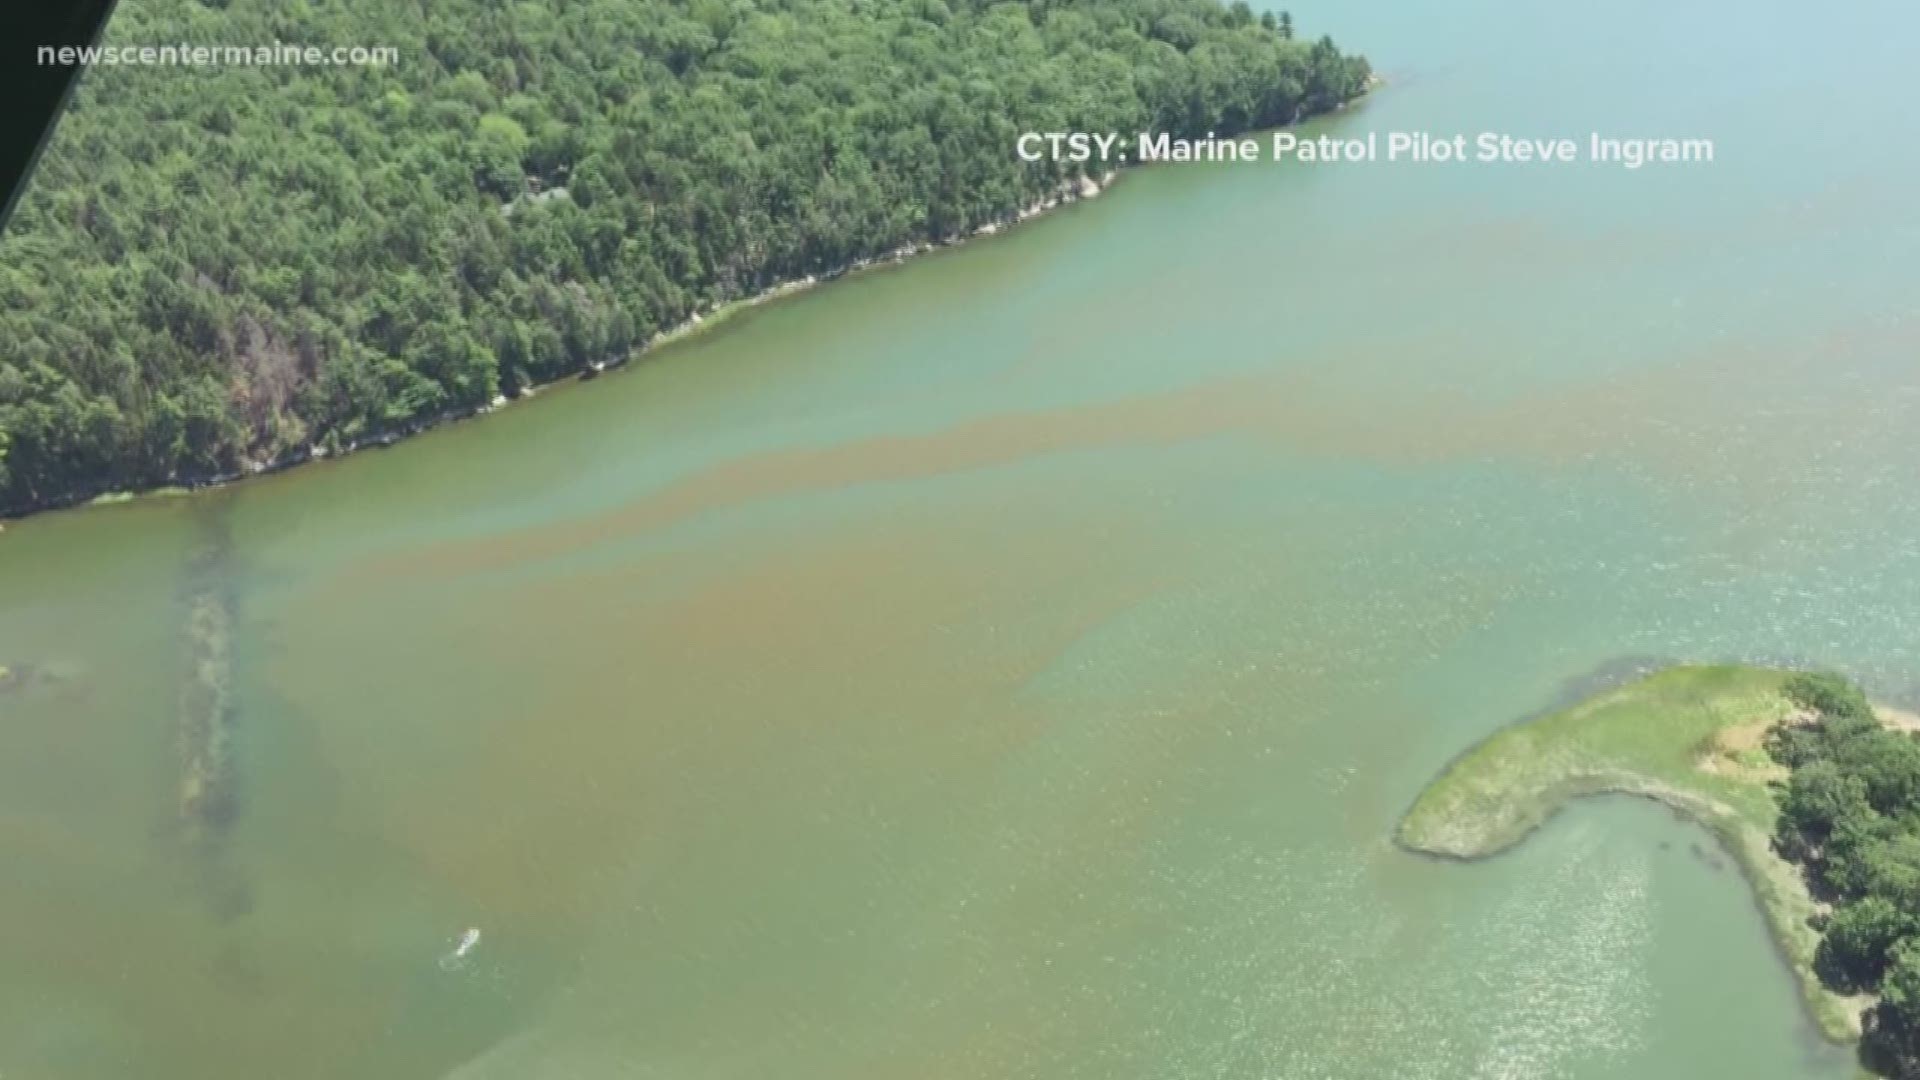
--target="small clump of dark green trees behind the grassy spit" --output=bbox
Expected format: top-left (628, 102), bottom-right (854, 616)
top-left (1768, 675), bottom-right (1920, 1080)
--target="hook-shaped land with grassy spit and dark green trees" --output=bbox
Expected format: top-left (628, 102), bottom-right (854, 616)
top-left (1394, 665), bottom-right (1920, 1076)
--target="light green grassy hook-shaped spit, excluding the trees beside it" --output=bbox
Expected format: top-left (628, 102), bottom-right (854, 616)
top-left (1396, 667), bottom-right (1864, 1042)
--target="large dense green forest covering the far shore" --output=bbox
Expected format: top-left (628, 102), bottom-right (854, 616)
top-left (0, 0), bottom-right (1369, 513)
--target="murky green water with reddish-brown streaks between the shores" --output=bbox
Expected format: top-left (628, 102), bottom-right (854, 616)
top-left (0, 0), bottom-right (1920, 1080)
